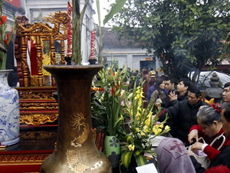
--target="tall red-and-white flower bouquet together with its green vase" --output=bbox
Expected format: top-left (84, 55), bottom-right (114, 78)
top-left (92, 65), bottom-right (128, 168)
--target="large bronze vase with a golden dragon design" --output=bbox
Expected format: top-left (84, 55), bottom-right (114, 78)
top-left (40, 65), bottom-right (112, 173)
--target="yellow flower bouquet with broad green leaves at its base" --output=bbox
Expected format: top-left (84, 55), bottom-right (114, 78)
top-left (121, 86), bottom-right (170, 168)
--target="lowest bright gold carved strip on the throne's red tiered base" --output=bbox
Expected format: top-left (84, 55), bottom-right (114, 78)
top-left (20, 113), bottom-right (58, 125)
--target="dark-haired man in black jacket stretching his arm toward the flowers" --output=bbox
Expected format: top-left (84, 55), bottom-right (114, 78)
top-left (158, 86), bottom-right (207, 143)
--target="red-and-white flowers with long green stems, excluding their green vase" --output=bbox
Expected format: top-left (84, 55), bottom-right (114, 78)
top-left (92, 62), bottom-right (128, 136)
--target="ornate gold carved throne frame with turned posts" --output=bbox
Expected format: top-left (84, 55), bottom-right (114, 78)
top-left (17, 11), bottom-right (68, 87)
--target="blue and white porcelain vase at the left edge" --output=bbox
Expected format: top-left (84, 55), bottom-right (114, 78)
top-left (0, 70), bottom-right (20, 146)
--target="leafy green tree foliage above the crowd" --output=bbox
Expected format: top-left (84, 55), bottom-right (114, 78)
top-left (110, 0), bottom-right (230, 77)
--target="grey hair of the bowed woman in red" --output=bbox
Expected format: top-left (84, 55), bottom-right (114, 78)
top-left (196, 106), bottom-right (221, 126)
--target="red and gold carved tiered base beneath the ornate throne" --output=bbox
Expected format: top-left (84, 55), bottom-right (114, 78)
top-left (16, 86), bottom-right (58, 125)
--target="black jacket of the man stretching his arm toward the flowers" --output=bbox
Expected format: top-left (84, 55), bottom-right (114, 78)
top-left (159, 100), bottom-right (204, 143)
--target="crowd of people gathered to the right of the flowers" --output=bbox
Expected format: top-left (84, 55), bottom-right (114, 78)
top-left (126, 69), bottom-right (230, 173)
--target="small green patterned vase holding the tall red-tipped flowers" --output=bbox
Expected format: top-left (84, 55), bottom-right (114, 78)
top-left (104, 136), bottom-right (120, 168)
